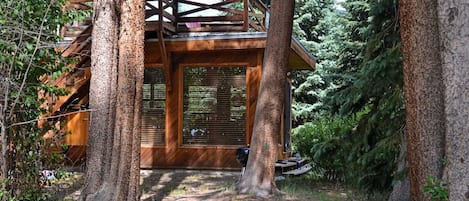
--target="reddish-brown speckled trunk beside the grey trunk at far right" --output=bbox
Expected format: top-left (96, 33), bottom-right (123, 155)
top-left (399, 0), bottom-right (445, 201)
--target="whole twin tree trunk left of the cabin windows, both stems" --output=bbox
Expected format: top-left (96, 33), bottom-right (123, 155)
top-left (81, 0), bottom-right (145, 201)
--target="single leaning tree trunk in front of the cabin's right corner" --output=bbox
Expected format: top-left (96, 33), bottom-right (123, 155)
top-left (238, 0), bottom-right (295, 197)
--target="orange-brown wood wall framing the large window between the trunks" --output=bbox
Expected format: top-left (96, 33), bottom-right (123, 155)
top-left (140, 49), bottom-right (262, 169)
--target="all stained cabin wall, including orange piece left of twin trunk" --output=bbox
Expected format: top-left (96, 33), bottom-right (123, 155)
top-left (66, 40), bottom-right (288, 169)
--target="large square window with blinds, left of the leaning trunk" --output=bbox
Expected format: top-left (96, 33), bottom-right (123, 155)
top-left (182, 67), bottom-right (246, 145)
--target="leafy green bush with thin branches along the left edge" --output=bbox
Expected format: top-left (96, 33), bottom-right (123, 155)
top-left (0, 0), bottom-right (86, 200)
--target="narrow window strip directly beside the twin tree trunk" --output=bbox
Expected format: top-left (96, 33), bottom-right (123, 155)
top-left (141, 68), bottom-right (166, 146)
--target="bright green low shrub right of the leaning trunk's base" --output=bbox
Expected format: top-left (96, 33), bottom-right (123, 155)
top-left (292, 115), bottom-right (358, 181)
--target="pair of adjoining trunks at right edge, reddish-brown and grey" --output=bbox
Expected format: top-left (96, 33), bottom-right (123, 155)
top-left (400, 0), bottom-right (469, 200)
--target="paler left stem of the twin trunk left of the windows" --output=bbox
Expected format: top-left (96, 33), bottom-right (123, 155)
top-left (82, 0), bottom-right (119, 200)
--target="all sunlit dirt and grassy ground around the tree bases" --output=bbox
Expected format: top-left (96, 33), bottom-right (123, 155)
top-left (48, 170), bottom-right (376, 201)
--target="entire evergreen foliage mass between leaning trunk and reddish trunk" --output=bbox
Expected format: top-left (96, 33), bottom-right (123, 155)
top-left (293, 0), bottom-right (405, 191)
